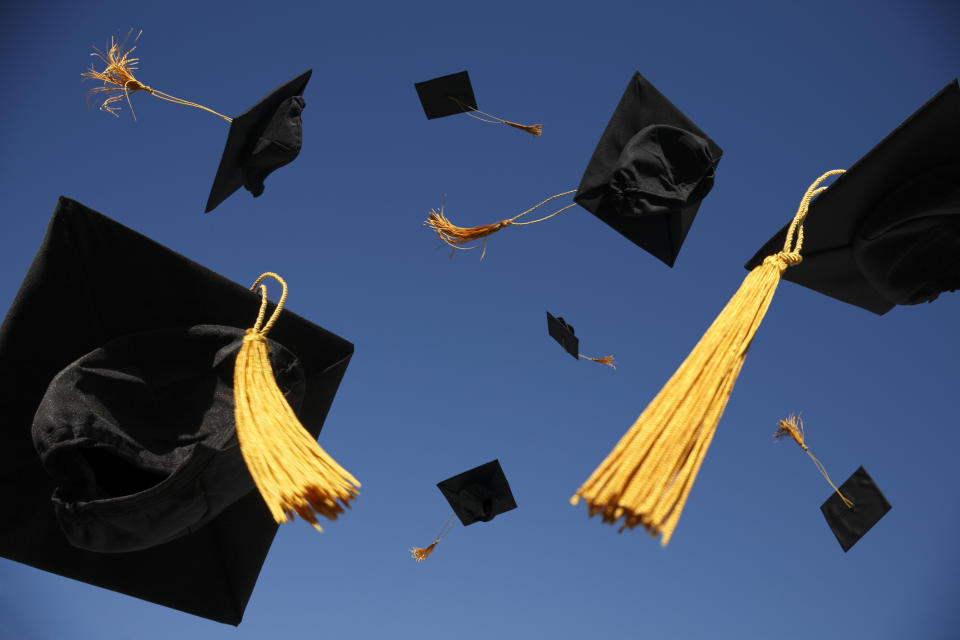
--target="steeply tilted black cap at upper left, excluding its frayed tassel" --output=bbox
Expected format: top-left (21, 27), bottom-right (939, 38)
top-left (206, 69), bottom-right (313, 213)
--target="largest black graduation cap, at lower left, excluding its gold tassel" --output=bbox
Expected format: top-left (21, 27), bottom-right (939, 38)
top-left (0, 198), bottom-right (353, 624)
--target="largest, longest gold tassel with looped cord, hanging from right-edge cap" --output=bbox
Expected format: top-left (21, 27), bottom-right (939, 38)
top-left (570, 170), bottom-right (843, 546)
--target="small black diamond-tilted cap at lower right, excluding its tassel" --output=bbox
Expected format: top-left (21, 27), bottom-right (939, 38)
top-left (820, 467), bottom-right (890, 551)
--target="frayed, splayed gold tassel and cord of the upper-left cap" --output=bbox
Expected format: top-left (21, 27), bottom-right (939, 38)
top-left (80, 30), bottom-right (233, 122)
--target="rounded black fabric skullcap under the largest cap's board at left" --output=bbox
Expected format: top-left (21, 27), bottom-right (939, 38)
top-left (33, 325), bottom-right (305, 553)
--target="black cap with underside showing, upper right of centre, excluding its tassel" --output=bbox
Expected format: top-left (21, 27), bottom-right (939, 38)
top-left (573, 73), bottom-right (723, 267)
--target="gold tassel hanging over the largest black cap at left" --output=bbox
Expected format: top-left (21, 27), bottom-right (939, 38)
top-left (233, 273), bottom-right (360, 531)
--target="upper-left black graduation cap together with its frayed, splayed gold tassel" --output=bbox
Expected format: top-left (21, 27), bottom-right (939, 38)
top-left (81, 31), bottom-right (312, 213)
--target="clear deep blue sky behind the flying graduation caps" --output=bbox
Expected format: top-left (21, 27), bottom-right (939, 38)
top-left (0, 0), bottom-right (960, 640)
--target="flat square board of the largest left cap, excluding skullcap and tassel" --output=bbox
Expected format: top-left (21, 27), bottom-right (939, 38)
top-left (0, 198), bottom-right (353, 624)
